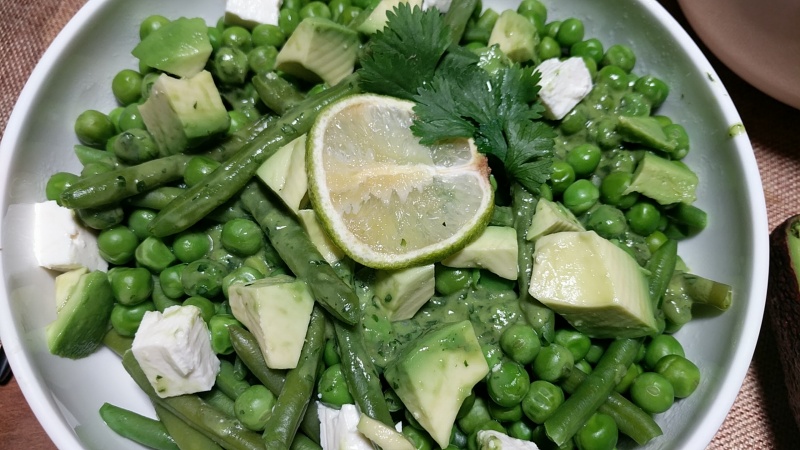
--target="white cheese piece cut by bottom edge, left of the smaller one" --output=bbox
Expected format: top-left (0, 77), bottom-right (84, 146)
top-left (317, 403), bottom-right (374, 450)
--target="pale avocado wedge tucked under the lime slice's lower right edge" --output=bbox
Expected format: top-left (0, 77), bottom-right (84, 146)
top-left (442, 226), bottom-right (518, 280)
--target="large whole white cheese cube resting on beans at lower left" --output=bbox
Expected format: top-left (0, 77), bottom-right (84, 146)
top-left (131, 306), bottom-right (219, 398)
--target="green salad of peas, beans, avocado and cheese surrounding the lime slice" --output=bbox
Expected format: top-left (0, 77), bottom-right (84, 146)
top-left (46, 0), bottom-right (731, 450)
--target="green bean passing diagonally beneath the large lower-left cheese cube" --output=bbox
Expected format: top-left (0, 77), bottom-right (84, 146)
top-left (122, 352), bottom-right (266, 450)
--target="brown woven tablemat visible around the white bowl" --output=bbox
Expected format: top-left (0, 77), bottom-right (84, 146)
top-left (0, 0), bottom-right (800, 450)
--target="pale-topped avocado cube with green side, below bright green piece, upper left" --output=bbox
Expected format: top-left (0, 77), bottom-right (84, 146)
top-left (139, 70), bottom-right (230, 156)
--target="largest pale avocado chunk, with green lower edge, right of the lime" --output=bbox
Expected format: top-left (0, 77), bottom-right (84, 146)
top-left (528, 231), bottom-right (658, 338)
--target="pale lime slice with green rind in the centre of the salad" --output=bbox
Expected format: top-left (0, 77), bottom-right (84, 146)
top-left (306, 94), bottom-right (494, 269)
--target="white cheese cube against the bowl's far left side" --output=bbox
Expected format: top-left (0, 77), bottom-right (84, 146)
top-left (33, 201), bottom-right (108, 272)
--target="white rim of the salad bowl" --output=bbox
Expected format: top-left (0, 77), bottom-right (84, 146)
top-left (0, 0), bottom-right (769, 448)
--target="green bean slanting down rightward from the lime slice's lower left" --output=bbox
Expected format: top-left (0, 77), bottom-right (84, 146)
top-left (241, 182), bottom-right (359, 324)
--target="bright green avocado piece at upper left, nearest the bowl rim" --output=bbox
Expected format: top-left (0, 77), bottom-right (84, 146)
top-left (131, 17), bottom-right (212, 77)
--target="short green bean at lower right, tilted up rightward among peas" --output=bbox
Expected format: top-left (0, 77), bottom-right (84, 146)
top-left (544, 339), bottom-right (641, 445)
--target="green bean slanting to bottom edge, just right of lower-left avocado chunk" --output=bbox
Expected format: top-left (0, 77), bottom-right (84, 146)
top-left (264, 307), bottom-right (325, 450)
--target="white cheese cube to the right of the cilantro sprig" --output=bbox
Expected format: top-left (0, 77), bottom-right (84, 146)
top-left (537, 57), bottom-right (592, 120)
